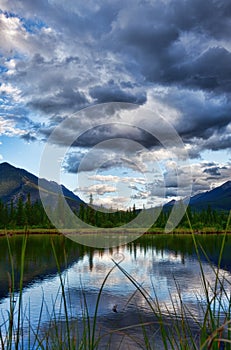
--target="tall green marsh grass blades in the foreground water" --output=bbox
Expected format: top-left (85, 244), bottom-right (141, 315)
top-left (0, 212), bottom-right (231, 350)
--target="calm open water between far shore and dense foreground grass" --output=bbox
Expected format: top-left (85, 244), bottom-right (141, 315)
top-left (0, 235), bottom-right (231, 349)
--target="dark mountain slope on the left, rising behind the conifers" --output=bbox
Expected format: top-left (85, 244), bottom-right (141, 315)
top-left (0, 163), bottom-right (84, 209)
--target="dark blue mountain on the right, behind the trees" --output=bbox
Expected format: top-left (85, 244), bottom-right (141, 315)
top-left (165, 181), bottom-right (231, 211)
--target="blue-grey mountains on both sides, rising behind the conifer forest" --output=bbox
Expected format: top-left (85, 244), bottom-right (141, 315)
top-left (0, 162), bottom-right (231, 211)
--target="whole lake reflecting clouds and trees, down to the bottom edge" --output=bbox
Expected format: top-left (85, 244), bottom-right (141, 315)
top-left (0, 234), bottom-right (231, 349)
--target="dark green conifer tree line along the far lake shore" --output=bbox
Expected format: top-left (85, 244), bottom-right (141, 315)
top-left (0, 194), bottom-right (228, 230)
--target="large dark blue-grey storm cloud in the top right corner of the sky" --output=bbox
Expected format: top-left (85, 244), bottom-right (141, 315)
top-left (103, 0), bottom-right (231, 92)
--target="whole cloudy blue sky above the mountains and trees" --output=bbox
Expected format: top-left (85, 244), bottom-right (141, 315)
top-left (0, 0), bottom-right (231, 208)
